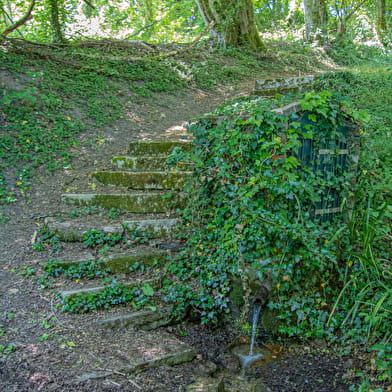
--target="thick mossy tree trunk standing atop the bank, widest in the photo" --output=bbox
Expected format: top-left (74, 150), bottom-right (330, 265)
top-left (196, 0), bottom-right (265, 49)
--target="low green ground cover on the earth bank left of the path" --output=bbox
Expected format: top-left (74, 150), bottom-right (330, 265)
top-left (0, 47), bottom-right (185, 208)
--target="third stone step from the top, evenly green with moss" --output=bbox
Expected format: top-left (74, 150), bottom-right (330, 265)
top-left (93, 171), bottom-right (192, 189)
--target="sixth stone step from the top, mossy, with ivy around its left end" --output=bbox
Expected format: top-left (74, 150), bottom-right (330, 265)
top-left (43, 250), bottom-right (169, 274)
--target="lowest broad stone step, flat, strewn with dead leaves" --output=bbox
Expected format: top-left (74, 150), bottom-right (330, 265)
top-left (75, 329), bottom-right (196, 382)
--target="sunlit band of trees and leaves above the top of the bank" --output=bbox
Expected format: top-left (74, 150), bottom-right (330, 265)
top-left (0, 0), bottom-right (392, 49)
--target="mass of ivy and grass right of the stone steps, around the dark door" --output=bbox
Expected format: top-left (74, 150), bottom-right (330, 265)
top-left (167, 67), bottom-right (392, 391)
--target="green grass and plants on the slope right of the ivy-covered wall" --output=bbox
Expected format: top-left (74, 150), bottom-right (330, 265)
top-left (314, 68), bottom-right (392, 342)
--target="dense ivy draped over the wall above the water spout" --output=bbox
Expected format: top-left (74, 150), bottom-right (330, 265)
top-left (167, 92), bottom-right (356, 328)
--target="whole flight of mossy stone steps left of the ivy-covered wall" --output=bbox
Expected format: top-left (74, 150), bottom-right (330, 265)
top-left (39, 142), bottom-right (196, 380)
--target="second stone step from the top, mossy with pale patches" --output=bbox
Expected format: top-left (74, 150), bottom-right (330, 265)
top-left (111, 156), bottom-right (190, 171)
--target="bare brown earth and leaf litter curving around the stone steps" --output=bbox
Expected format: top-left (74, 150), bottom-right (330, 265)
top-left (0, 44), bottom-right (364, 392)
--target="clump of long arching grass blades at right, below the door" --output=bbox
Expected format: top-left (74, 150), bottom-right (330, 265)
top-left (329, 198), bottom-right (392, 343)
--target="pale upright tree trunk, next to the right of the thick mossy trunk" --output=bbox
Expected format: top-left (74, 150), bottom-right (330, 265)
top-left (304, 0), bottom-right (328, 41)
